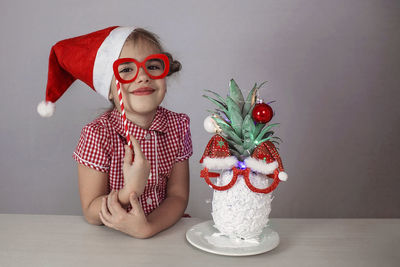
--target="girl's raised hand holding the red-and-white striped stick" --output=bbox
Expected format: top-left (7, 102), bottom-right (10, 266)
top-left (123, 135), bottom-right (150, 196)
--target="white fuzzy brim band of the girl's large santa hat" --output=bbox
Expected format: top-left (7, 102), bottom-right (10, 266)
top-left (93, 27), bottom-right (135, 99)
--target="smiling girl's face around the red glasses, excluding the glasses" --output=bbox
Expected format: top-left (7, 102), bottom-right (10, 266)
top-left (109, 41), bottom-right (167, 118)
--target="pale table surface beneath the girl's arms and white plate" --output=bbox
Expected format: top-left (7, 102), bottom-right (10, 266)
top-left (0, 214), bottom-right (400, 267)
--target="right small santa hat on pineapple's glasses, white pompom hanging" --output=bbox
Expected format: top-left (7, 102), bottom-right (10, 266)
top-left (244, 141), bottom-right (288, 181)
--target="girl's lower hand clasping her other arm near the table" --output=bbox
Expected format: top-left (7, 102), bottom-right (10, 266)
top-left (99, 190), bottom-right (152, 238)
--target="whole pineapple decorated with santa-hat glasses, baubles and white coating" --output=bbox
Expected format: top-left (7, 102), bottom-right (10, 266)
top-left (200, 79), bottom-right (287, 240)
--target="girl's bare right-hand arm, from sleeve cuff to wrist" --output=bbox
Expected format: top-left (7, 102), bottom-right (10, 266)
top-left (147, 160), bottom-right (189, 237)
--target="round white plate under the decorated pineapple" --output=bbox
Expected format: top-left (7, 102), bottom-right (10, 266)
top-left (186, 220), bottom-right (279, 256)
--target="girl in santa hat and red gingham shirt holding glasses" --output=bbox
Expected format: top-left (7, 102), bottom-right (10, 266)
top-left (38, 27), bottom-right (193, 238)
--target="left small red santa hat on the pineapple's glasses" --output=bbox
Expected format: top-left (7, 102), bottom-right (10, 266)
top-left (200, 134), bottom-right (238, 170)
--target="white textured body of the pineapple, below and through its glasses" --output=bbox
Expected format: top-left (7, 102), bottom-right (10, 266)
top-left (211, 170), bottom-right (273, 239)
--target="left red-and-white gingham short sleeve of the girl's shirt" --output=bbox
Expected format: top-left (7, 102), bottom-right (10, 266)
top-left (73, 124), bottom-right (110, 172)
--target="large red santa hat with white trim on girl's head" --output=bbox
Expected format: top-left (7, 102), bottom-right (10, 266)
top-left (37, 26), bottom-right (135, 117)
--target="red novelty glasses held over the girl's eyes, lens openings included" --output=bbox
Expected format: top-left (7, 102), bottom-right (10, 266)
top-left (113, 54), bottom-right (169, 83)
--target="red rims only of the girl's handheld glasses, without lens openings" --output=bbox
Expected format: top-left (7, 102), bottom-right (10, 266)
top-left (113, 54), bottom-right (169, 83)
